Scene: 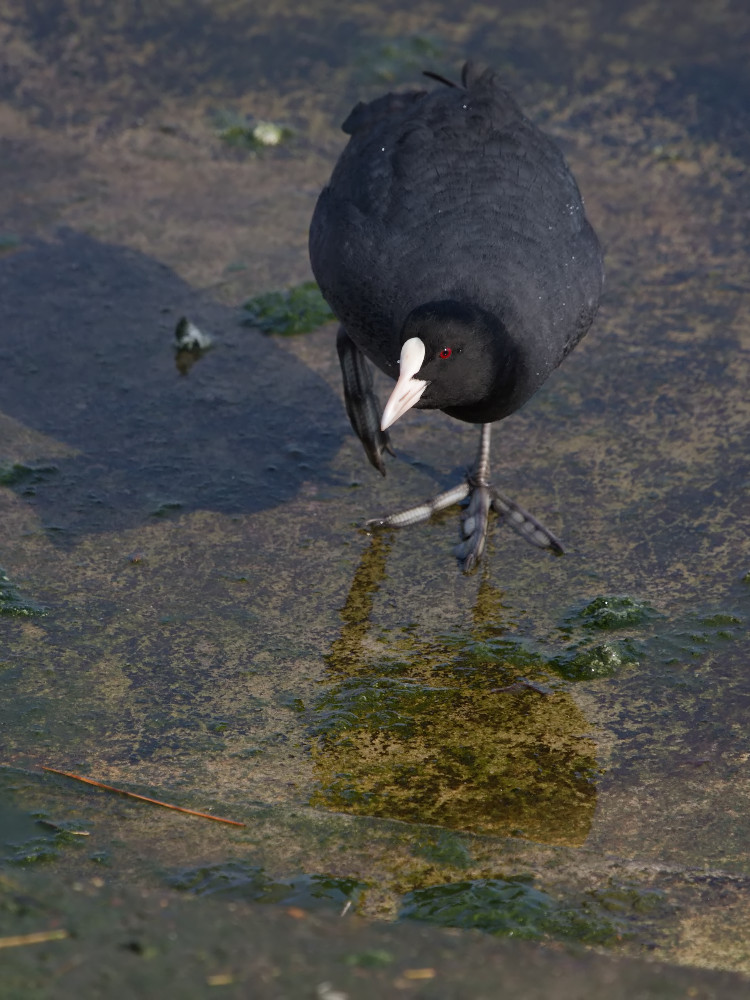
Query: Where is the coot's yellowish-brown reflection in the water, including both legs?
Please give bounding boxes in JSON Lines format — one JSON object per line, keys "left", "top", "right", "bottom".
{"left": 311, "top": 534, "right": 597, "bottom": 845}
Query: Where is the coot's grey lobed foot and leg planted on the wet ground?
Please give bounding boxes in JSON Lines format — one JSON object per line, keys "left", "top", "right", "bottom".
{"left": 367, "top": 424, "right": 563, "bottom": 573}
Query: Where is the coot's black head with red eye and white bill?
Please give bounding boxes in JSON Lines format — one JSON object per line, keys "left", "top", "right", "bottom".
{"left": 381, "top": 299, "right": 516, "bottom": 430}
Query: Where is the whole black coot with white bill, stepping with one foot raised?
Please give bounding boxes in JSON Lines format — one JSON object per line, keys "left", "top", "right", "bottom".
{"left": 310, "top": 63, "right": 603, "bottom": 571}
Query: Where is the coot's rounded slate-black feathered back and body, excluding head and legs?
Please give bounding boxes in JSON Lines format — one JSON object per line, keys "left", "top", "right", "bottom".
{"left": 310, "top": 64, "right": 602, "bottom": 419}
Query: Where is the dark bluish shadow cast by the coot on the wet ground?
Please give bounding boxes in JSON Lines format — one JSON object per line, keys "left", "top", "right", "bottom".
{"left": 0, "top": 231, "right": 347, "bottom": 543}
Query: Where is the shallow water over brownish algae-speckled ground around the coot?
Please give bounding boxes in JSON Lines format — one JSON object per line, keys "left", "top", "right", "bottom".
{"left": 0, "top": 2, "right": 750, "bottom": 996}
